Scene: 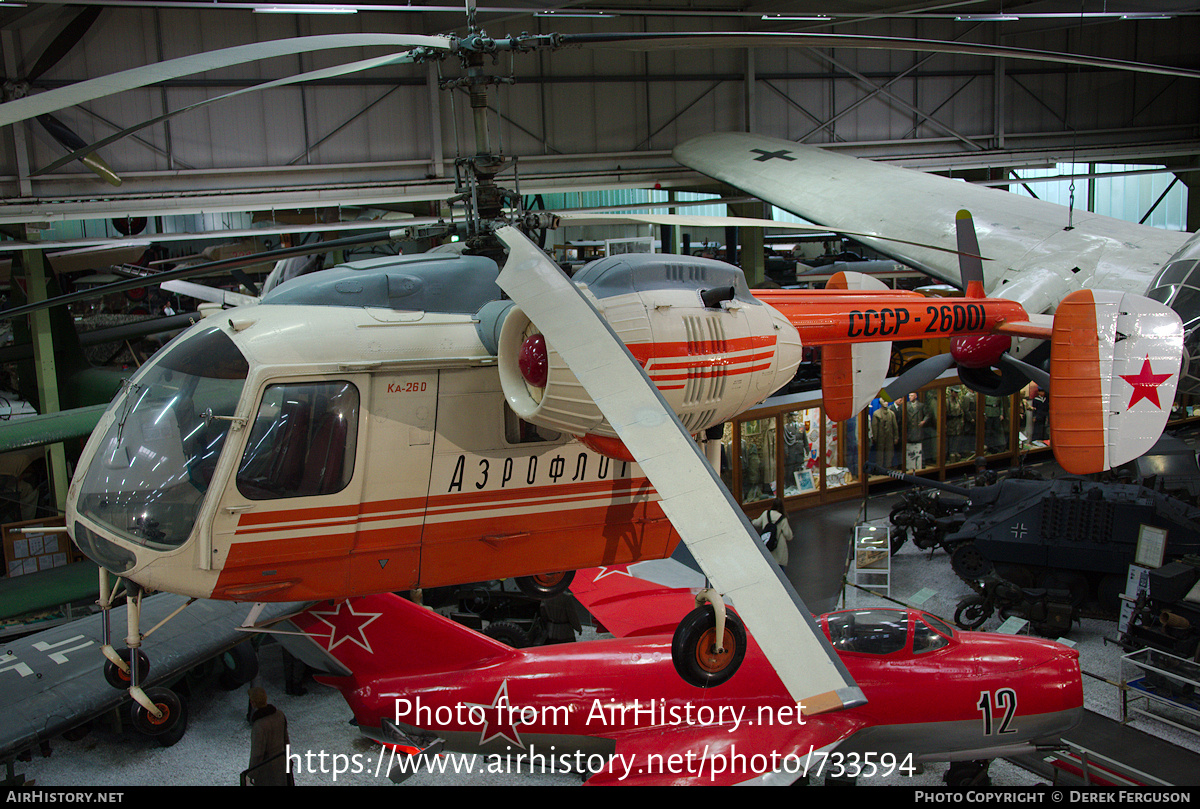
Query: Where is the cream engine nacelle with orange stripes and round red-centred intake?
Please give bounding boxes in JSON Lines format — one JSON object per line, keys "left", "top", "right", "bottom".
{"left": 497, "top": 253, "right": 800, "bottom": 457}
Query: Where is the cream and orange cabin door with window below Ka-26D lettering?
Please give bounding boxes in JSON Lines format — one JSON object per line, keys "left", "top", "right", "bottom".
{"left": 212, "top": 373, "right": 371, "bottom": 601}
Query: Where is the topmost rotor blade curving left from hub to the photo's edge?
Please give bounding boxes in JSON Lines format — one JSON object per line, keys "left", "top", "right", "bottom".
{"left": 0, "top": 34, "right": 450, "bottom": 126}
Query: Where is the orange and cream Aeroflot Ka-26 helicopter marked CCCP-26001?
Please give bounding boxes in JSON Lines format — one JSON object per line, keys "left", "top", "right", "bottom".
{"left": 60, "top": 217, "right": 1182, "bottom": 734}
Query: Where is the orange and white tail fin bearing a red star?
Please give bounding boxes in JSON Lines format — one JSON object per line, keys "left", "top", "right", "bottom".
{"left": 1050, "top": 289, "right": 1183, "bottom": 474}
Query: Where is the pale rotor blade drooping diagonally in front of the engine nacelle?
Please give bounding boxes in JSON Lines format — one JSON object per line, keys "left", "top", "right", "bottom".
{"left": 497, "top": 227, "right": 865, "bottom": 714}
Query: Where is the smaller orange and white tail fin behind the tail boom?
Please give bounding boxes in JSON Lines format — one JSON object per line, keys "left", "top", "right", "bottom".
{"left": 821, "top": 272, "right": 892, "bottom": 421}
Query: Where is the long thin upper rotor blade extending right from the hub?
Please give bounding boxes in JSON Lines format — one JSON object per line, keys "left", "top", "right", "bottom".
{"left": 557, "top": 31, "right": 1200, "bottom": 79}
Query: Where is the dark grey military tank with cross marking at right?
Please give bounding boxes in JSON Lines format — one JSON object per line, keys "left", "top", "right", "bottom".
{"left": 943, "top": 477, "right": 1200, "bottom": 611}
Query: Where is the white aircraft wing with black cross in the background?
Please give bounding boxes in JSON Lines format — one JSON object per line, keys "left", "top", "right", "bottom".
{"left": 674, "top": 132, "right": 1189, "bottom": 313}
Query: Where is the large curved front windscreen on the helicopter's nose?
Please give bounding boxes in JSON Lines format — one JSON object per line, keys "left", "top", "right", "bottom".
{"left": 77, "top": 328, "right": 250, "bottom": 547}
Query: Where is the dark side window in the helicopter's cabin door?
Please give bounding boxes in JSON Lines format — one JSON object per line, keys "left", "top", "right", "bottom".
{"left": 238, "top": 382, "right": 359, "bottom": 501}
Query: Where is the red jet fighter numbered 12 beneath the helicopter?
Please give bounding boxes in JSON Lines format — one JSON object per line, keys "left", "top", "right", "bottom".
{"left": 281, "top": 567, "right": 1084, "bottom": 785}
